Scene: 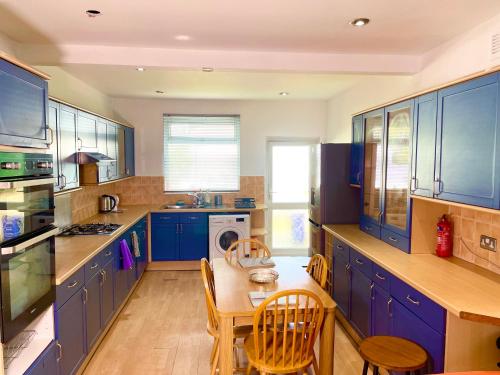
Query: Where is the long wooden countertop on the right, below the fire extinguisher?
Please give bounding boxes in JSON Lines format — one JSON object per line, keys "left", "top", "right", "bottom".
{"left": 323, "top": 225, "right": 500, "bottom": 325}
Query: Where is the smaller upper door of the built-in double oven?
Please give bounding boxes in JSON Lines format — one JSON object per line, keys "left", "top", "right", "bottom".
{"left": 0, "top": 178, "right": 56, "bottom": 242}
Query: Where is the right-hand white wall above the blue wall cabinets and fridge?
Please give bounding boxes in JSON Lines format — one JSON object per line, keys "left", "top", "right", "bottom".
{"left": 327, "top": 15, "right": 500, "bottom": 142}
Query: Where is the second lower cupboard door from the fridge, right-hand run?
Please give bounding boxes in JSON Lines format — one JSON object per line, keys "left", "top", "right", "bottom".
{"left": 350, "top": 266, "right": 373, "bottom": 337}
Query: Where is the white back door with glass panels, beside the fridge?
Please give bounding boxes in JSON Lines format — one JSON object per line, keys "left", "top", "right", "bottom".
{"left": 268, "top": 142, "right": 314, "bottom": 256}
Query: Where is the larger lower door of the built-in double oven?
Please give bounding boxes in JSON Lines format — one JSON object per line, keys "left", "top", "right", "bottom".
{"left": 0, "top": 227, "right": 59, "bottom": 343}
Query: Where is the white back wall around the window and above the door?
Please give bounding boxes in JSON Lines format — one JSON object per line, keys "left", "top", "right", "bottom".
{"left": 112, "top": 98, "right": 327, "bottom": 176}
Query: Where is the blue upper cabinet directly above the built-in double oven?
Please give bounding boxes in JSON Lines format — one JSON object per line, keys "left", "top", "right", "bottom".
{"left": 0, "top": 59, "right": 50, "bottom": 148}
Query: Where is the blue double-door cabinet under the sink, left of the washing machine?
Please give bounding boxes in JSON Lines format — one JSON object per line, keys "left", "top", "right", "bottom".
{"left": 151, "top": 213, "right": 208, "bottom": 261}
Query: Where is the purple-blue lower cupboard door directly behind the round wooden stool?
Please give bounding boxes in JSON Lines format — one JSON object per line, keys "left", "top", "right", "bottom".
{"left": 391, "top": 300, "right": 445, "bottom": 374}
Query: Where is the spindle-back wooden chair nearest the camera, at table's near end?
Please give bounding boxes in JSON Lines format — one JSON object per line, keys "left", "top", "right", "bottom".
{"left": 244, "top": 289, "right": 324, "bottom": 375}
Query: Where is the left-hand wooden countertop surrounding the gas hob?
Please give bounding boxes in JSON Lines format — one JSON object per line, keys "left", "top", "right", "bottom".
{"left": 56, "top": 205, "right": 152, "bottom": 285}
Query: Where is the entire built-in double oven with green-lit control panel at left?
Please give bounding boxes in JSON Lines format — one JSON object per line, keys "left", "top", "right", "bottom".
{"left": 0, "top": 152, "right": 55, "bottom": 342}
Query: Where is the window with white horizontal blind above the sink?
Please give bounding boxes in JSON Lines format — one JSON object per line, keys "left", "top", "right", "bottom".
{"left": 163, "top": 115, "right": 240, "bottom": 192}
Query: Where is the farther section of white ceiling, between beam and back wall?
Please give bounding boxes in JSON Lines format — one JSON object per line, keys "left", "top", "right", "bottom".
{"left": 57, "top": 64, "right": 376, "bottom": 100}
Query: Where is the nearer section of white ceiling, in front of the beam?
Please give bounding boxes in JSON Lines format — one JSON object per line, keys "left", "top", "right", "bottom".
{"left": 0, "top": 0, "right": 500, "bottom": 54}
